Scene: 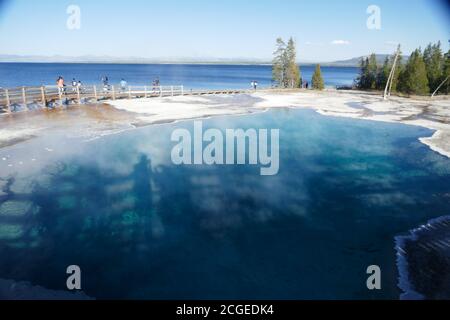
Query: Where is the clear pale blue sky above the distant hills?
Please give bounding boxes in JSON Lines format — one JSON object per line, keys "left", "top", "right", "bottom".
{"left": 0, "top": 0, "right": 450, "bottom": 61}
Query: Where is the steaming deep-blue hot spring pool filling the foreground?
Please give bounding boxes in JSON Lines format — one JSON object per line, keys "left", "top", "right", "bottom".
{"left": 0, "top": 109, "right": 450, "bottom": 299}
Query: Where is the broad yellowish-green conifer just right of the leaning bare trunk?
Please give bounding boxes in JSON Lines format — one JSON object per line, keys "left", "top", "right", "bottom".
{"left": 399, "top": 49, "right": 430, "bottom": 95}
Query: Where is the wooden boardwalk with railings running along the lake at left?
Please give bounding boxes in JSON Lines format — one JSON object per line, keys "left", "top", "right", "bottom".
{"left": 0, "top": 85, "right": 251, "bottom": 113}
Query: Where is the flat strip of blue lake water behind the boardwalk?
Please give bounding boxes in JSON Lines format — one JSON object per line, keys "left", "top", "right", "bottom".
{"left": 0, "top": 63, "right": 358, "bottom": 89}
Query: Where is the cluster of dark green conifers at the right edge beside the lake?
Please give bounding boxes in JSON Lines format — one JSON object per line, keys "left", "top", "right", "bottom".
{"left": 356, "top": 42, "right": 450, "bottom": 95}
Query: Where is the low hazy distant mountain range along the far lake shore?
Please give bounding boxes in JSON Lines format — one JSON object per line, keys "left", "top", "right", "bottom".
{"left": 0, "top": 54, "right": 407, "bottom": 67}
